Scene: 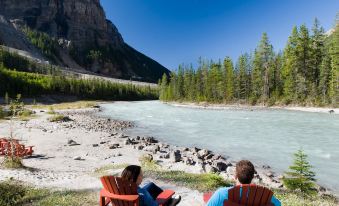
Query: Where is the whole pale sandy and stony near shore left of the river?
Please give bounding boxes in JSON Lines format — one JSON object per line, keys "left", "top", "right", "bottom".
{"left": 0, "top": 103, "right": 338, "bottom": 205}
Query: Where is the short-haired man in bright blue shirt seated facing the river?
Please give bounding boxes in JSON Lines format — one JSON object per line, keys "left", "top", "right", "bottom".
{"left": 207, "top": 160, "right": 281, "bottom": 206}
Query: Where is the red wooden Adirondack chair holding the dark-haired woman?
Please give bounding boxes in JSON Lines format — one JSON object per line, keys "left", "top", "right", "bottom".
{"left": 100, "top": 176, "right": 174, "bottom": 206}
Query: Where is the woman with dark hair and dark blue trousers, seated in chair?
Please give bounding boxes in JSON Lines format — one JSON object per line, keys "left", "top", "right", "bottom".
{"left": 121, "top": 165, "right": 181, "bottom": 206}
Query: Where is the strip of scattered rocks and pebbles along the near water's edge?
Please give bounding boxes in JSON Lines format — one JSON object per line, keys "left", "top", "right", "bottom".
{"left": 56, "top": 109, "right": 292, "bottom": 188}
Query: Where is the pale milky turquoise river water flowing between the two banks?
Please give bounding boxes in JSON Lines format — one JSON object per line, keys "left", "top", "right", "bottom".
{"left": 101, "top": 101, "right": 339, "bottom": 194}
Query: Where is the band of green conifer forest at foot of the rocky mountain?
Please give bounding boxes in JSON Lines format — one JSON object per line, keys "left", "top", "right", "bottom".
{"left": 0, "top": 48, "right": 159, "bottom": 100}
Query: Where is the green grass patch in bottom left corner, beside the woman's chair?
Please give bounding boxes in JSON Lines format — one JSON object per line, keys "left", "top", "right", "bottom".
{"left": 0, "top": 180, "right": 98, "bottom": 206}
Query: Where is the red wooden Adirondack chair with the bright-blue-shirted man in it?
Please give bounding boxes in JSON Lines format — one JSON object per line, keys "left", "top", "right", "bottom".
{"left": 204, "top": 184, "right": 273, "bottom": 206}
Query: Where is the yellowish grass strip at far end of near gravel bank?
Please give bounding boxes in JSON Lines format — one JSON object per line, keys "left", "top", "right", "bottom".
{"left": 31, "top": 101, "right": 98, "bottom": 111}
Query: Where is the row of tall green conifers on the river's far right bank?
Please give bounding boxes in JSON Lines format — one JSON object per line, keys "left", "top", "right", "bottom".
{"left": 159, "top": 19, "right": 339, "bottom": 106}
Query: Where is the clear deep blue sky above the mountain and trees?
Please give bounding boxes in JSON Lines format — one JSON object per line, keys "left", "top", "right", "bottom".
{"left": 101, "top": 0, "right": 339, "bottom": 70}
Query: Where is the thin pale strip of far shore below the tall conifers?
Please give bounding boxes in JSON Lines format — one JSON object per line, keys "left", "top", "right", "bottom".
{"left": 166, "top": 102, "right": 339, "bottom": 115}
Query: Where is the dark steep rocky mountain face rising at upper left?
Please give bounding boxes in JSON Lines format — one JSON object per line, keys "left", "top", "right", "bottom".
{"left": 0, "top": 0, "right": 169, "bottom": 82}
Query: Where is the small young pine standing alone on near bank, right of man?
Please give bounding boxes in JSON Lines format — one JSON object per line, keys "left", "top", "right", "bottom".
{"left": 283, "top": 149, "right": 315, "bottom": 195}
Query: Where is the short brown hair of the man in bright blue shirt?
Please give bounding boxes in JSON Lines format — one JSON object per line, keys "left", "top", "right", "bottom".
{"left": 235, "top": 160, "right": 255, "bottom": 184}
